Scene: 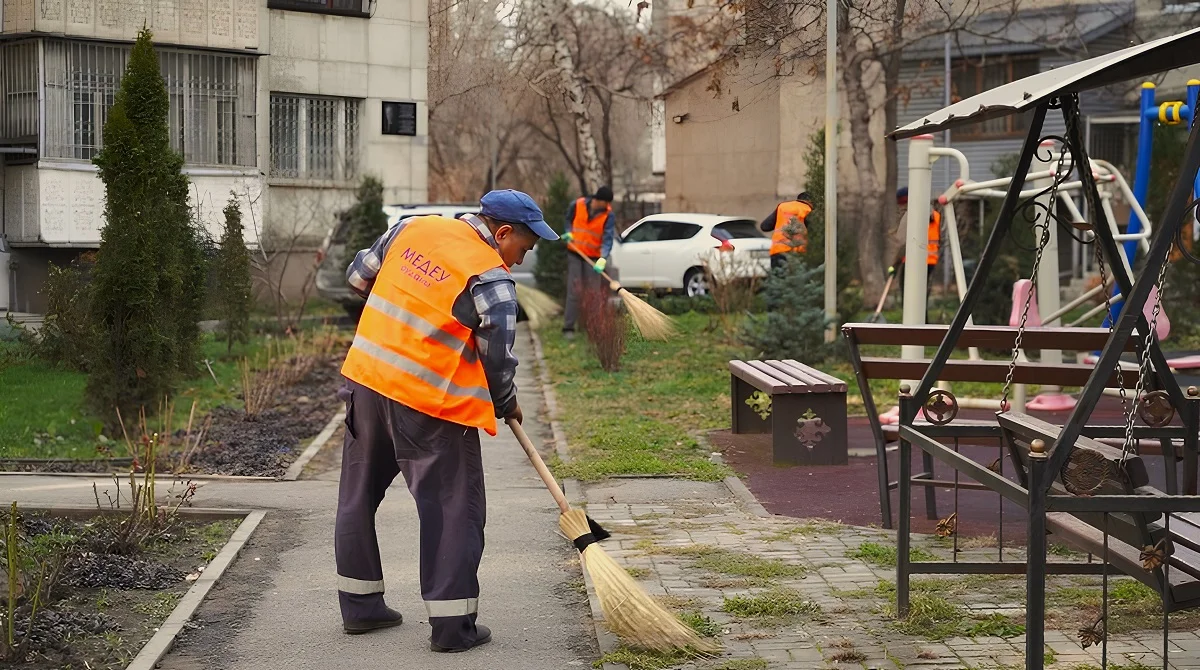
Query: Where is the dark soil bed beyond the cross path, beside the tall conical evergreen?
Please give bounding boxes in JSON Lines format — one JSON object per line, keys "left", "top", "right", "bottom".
{"left": 0, "top": 353, "right": 343, "bottom": 477}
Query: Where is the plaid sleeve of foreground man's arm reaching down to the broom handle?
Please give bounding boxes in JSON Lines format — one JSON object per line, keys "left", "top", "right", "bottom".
{"left": 468, "top": 268, "right": 517, "bottom": 417}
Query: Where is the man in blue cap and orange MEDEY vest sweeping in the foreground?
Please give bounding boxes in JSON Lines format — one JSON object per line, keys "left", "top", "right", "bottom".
{"left": 334, "top": 191, "right": 558, "bottom": 652}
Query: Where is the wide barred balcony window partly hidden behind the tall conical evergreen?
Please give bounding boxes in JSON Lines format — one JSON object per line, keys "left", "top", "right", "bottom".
{"left": 46, "top": 41, "right": 257, "bottom": 166}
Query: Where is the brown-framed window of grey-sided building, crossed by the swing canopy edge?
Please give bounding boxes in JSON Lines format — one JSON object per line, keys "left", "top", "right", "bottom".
{"left": 950, "top": 56, "right": 1039, "bottom": 139}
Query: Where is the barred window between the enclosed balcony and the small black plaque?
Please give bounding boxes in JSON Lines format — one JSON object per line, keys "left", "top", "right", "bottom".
{"left": 271, "top": 94, "right": 362, "bottom": 181}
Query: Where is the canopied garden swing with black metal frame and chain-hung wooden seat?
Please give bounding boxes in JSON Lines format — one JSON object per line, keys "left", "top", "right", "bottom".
{"left": 893, "top": 29, "right": 1200, "bottom": 670}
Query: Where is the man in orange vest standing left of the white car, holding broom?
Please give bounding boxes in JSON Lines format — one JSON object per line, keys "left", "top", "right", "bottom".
{"left": 563, "top": 186, "right": 617, "bottom": 339}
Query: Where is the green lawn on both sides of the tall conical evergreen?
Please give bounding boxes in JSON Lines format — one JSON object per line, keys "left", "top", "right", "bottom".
{"left": 0, "top": 335, "right": 282, "bottom": 459}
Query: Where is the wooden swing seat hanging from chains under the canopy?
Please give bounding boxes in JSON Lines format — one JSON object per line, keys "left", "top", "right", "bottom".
{"left": 998, "top": 412, "right": 1200, "bottom": 612}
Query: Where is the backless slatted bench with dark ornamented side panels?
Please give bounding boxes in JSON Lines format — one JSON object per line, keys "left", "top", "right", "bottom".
{"left": 730, "top": 360, "right": 848, "bottom": 465}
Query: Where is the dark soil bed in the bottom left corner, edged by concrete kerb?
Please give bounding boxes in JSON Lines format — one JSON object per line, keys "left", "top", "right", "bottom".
{"left": 0, "top": 513, "right": 240, "bottom": 670}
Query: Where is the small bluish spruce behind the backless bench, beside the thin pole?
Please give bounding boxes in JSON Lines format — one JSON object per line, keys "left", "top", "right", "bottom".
{"left": 742, "top": 256, "right": 830, "bottom": 364}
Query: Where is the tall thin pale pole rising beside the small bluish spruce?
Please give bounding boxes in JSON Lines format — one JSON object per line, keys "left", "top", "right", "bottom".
{"left": 824, "top": 0, "right": 838, "bottom": 342}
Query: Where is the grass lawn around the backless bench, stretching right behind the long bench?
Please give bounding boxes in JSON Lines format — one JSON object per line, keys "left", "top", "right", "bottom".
{"left": 539, "top": 300, "right": 1128, "bottom": 480}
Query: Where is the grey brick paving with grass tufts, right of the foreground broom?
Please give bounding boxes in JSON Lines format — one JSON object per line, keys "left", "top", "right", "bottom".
{"left": 587, "top": 480, "right": 1200, "bottom": 670}
